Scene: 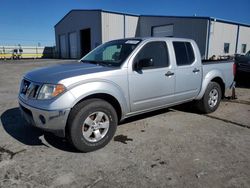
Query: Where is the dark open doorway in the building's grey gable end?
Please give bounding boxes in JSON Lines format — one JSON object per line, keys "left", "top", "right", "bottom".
{"left": 81, "top": 28, "right": 91, "bottom": 57}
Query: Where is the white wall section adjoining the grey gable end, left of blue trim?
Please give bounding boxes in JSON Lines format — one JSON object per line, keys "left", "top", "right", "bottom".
{"left": 102, "top": 12, "right": 124, "bottom": 43}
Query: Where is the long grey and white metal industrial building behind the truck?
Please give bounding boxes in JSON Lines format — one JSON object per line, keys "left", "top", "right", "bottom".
{"left": 55, "top": 10, "right": 250, "bottom": 59}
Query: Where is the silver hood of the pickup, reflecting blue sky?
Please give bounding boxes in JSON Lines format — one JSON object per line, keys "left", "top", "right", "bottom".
{"left": 24, "top": 63, "right": 116, "bottom": 83}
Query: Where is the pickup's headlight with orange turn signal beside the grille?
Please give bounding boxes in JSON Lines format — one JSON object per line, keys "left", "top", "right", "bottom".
{"left": 38, "top": 84, "right": 65, "bottom": 99}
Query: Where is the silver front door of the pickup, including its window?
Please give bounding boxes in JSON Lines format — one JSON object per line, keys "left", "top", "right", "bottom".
{"left": 128, "top": 41, "right": 175, "bottom": 112}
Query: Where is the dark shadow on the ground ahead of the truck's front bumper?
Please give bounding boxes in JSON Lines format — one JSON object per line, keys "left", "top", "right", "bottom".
{"left": 1, "top": 108, "right": 77, "bottom": 152}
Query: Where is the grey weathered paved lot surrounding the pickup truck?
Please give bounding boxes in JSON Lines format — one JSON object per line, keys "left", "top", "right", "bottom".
{"left": 0, "top": 59, "right": 250, "bottom": 188}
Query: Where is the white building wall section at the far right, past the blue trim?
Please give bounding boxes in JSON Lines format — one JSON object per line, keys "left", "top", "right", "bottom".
{"left": 237, "top": 26, "right": 250, "bottom": 54}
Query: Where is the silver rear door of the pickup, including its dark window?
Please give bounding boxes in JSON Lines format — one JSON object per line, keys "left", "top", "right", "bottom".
{"left": 173, "top": 41, "right": 202, "bottom": 101}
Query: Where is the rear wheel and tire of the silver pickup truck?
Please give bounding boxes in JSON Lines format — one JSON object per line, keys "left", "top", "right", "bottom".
{"left": 197, "top": 82, "right": 222, "bottom": 114}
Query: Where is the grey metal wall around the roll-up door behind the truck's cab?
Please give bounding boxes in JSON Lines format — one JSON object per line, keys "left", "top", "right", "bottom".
{"left": 140, "top": 16, "right": 207, "bottom": 58}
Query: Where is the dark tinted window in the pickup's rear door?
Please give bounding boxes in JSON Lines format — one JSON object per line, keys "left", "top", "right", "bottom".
{"left": 173, "top": 42, "right": 195, "bottom": 66}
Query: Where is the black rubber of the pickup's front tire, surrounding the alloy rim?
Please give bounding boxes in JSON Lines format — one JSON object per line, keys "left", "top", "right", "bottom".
{"left": 70, "top": 100, "right": 117, "bottom": 152}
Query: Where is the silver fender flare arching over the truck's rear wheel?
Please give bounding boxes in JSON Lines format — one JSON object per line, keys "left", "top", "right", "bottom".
{"left": 196, "top": 70, "right": 224, "bottom": 100}
